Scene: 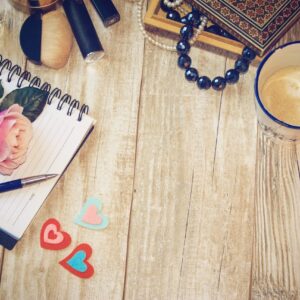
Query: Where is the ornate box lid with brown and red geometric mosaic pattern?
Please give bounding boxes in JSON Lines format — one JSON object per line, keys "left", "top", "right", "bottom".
{"left": 188, "top": 0, "right": 300, "bottom": 56}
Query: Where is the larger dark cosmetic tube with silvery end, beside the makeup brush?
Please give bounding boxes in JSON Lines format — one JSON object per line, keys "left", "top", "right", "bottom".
{"left": 63, "top": 0, "right": 104, "bottom": 62}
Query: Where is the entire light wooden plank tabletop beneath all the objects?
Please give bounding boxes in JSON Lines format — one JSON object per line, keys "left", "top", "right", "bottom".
{"left": 0, "top": 0, "right": 300, "bottom": 300}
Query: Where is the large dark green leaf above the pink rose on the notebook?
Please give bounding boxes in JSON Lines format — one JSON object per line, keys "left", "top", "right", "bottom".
{"left": 0, "top": 87, "right": 48, "bottom": 122}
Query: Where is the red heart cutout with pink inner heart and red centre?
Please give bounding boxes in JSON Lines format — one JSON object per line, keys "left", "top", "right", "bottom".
{"left": 40, "top": 218, "right": 71, "bottom": 250}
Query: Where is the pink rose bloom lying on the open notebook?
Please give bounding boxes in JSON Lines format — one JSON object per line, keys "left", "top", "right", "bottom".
{"left": 0, "top": 104, "right": 32, "bottom": 175}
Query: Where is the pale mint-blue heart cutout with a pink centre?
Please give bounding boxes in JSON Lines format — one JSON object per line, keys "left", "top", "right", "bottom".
{"left": 74, "top": 198, "right": 108, "bottom": 230}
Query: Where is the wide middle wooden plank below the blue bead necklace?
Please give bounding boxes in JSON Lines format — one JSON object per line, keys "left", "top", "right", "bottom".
{"left": 125, "top": 28, "right": 256, "bottom": 299}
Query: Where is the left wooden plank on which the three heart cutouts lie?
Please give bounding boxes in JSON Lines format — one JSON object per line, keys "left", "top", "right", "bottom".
{"left": 0, "top": 1, "right": 144, "bottom": 300}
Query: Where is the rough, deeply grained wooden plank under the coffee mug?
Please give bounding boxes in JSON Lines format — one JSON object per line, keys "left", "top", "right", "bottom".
{"left": 252, "top": 22, "right": 300, "bottom": 299}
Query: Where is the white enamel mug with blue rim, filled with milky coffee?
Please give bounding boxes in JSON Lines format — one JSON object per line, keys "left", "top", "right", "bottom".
{"left": 255, "top": 42, "right": 300, "bottom": 141}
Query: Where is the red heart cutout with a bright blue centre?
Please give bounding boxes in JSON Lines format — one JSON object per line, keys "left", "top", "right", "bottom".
{"left": 59, "top": 244, "right": 94, "bottom": 278}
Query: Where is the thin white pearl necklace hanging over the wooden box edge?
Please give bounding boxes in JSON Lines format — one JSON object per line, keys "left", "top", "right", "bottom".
{"left": 137, "top": 0, "right": 207, "bottom": 52}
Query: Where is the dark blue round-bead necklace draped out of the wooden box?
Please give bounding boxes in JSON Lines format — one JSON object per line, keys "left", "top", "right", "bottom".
{"left": 160, "top": 0, "right": 256, "bottom": 91}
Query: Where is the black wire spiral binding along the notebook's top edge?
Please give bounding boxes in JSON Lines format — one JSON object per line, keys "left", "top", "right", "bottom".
{"left": 0, "top": 54, "right": 89, "bottom": 121}
